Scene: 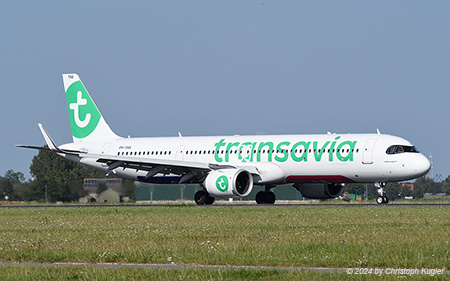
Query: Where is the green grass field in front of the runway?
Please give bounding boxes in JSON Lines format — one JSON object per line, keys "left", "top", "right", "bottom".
{"left": 0, "top": 203, "right": 450, "bottom": 280}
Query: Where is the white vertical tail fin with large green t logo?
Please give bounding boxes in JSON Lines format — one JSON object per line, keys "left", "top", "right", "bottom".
{"left": 63, "top": 74, "right": 120, "bottom": 142}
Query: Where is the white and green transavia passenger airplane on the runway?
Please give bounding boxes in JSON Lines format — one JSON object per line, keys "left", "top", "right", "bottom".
{"left": 17, "top": 73, "right": 431, "bottom": 205}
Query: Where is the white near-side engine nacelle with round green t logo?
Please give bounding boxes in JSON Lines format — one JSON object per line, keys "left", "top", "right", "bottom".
{"left": 203, "top": 169, "right": 253, "bottom": 198}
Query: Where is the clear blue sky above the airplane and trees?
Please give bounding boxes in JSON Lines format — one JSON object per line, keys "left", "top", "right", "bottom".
{"left": 0, "top": 1, "right": 450, "bottom": 178}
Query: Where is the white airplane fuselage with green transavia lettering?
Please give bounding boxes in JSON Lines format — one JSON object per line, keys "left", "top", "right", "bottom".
{"left": 61, "top": 134, "right": 430, "bottom": 185}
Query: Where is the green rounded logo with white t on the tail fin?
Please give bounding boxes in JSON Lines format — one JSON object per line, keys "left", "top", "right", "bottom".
{"left": 66, "top": 81, "right": 101, "bottom": 139}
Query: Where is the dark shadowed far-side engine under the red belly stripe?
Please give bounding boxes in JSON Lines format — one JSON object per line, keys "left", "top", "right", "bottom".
{"left": 294, "top": 183, "right": 344, "bottom": 199}
